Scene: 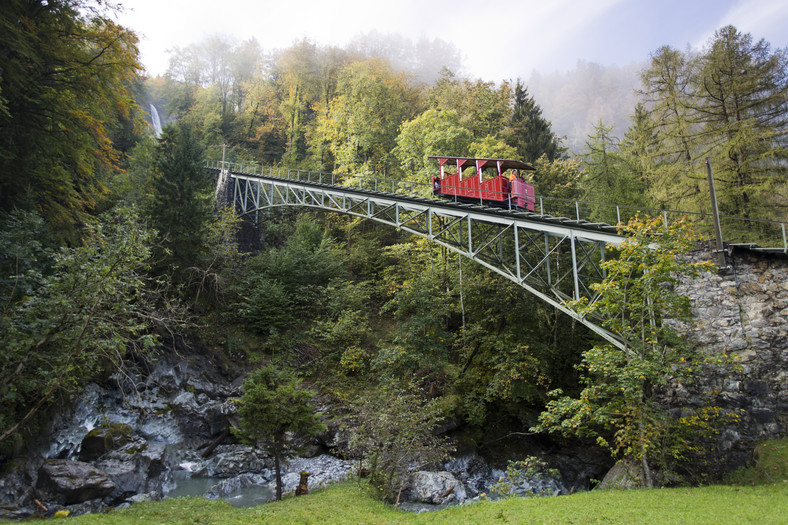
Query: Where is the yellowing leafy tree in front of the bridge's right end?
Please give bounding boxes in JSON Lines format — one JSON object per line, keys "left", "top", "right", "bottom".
{"left": 535, "top": 218, "right": 712, "bottom": 486}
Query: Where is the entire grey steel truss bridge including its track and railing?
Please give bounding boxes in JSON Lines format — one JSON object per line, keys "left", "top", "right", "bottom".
{"left": 206, "top": 162, "right": 788, "bottom": 348}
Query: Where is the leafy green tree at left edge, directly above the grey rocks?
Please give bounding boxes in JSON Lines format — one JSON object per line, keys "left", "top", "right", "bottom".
{"left": 0, "top": 210, "right": 168, "bottom": 447}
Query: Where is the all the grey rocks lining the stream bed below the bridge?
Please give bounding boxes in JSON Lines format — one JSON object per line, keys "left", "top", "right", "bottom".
{"left": 0, "top": 340, "right": 616, "bottom": 519}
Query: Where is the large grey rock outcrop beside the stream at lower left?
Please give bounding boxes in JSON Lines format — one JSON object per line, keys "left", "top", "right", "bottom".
{"left": 0, "top": 344, "right": 243, "bottom": 518}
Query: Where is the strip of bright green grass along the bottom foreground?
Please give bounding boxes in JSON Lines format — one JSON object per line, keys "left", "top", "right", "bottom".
{"left": 43, "top": 482, "right": 788, "bottom": 525}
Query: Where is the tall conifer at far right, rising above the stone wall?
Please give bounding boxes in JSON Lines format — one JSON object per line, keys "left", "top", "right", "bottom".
{"left": 691, "top": 26, "right": 788, "bottom": 217}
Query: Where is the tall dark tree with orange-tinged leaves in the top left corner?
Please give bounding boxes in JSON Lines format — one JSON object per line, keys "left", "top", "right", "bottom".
{"left": 0, "top": 0, "right": 141, "bottom": 233}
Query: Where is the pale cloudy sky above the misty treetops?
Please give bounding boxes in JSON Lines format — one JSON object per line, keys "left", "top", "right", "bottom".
{"left": 119, "top": 0, "right": 788, "bottom": 82}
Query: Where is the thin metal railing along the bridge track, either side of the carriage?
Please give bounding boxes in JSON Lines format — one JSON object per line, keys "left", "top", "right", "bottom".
{"left": 206, "top": 161, "right": 788, "bottom": 253}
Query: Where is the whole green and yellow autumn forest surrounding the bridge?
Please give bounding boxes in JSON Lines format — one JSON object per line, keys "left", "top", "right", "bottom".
{"left": 0, "top": 0, "right": 788, "bottom": 500}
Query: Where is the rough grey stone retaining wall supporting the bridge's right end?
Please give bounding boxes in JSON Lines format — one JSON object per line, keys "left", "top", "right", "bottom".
{"left": 670, "top": 247, "right": 788, "bottom": 464}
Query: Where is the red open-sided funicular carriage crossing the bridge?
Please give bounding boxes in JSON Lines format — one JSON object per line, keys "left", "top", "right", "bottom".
{"left": 428, "top": 156, "right": 536, "bottom": 211}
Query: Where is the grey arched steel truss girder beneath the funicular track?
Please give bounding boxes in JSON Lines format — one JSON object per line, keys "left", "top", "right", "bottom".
{"left": 223, "top": 169, "right": 624, "bottom": 348}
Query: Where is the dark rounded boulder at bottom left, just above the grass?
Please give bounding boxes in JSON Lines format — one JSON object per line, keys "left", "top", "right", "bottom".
{"left": 36, "top": 459, "right": 115, "bottom": 505}
